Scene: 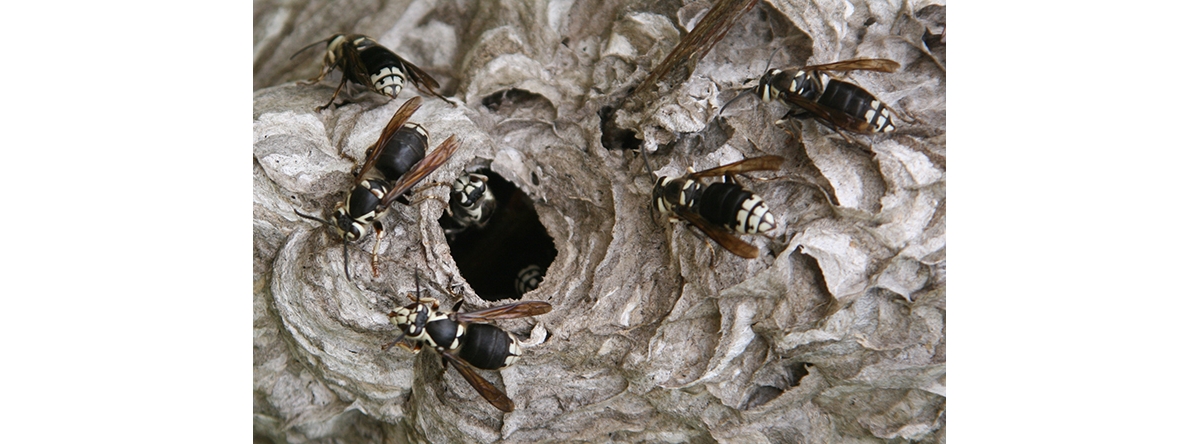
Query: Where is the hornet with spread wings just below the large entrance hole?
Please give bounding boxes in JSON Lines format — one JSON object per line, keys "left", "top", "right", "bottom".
{"left": 383, "top": 289, "right": 551, "bottom": 412}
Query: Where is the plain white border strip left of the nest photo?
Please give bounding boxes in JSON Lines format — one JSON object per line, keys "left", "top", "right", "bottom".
{"left": 0, "top": 1, "right": 253, "bottom": 443}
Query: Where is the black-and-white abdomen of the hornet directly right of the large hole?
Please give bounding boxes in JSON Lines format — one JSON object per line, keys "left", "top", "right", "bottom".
{"left": 696, "top": 182, "right": 775, "bottom": 234}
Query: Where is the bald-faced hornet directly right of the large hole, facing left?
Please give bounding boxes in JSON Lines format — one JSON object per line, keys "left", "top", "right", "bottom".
{"left": 642, "top": 151, "right": 784, "bottom": 259}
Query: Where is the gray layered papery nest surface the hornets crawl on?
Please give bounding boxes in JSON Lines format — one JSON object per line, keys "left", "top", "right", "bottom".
{"left": 253, "top": 0, "right": 946, "bottom": 443}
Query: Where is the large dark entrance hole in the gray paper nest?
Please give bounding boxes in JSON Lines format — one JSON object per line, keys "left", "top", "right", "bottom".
{"left": 438, "top": 169, "right": 558, "bottom": 301}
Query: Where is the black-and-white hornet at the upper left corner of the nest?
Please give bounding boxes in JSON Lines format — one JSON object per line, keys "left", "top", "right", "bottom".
{"left": 292, "top": 34, "right": 449, "bottom": 112}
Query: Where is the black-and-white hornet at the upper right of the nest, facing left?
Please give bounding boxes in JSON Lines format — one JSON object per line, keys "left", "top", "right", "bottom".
{"left": 753, "top": 59, "right": 900, "bottom": 140}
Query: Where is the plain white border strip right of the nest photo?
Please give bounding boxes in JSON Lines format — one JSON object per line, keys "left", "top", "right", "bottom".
{"left": 947, "top": 0, "right": 1200, "bottom": 443}
